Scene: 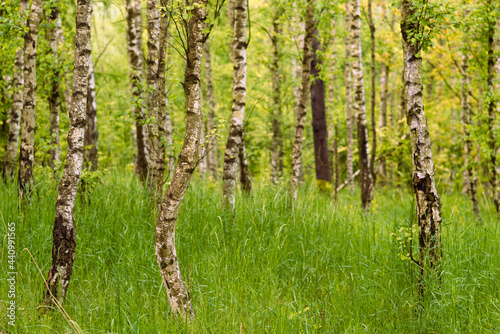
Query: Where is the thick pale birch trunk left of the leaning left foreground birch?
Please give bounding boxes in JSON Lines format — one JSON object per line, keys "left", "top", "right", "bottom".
{"left": 18, "top": 0, "right": 43, "bottom": 197}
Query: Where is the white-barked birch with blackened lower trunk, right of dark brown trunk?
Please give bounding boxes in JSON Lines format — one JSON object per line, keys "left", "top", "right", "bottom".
{"left": 351, "top": 0, "right": 373, "bottom": 212}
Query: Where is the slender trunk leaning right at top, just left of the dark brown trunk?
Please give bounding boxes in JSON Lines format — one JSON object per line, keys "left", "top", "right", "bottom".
{"left": 290, "top": 0, "right": 315, "bottom": 200}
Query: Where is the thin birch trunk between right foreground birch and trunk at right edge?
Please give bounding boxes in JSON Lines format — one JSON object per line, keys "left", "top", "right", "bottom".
{"left": 461, "top": 53, "right": 481, "bottom": 216}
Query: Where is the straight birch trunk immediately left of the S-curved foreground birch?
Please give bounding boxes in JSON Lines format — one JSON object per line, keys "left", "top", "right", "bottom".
{"left": 146, "top": 0, "right": 165, "bottom": 196}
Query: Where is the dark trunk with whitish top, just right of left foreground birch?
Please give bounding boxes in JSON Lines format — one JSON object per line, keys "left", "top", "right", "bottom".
{"left": 84, "top": 57, "right": 99, "bottom": 171}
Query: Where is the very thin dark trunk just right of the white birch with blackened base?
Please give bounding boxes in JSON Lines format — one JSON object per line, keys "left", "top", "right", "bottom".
{"left": 368, "top": 0, "right": 377, "bottom": 183}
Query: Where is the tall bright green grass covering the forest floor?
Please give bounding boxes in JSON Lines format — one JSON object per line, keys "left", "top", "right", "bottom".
{"left": 0, "top": 171, "right": 500, "bottom": 333}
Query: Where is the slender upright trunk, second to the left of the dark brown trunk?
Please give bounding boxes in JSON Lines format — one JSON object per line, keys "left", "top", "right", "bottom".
{"left": 271, "top": 4, "right": 283, "bottom": 184}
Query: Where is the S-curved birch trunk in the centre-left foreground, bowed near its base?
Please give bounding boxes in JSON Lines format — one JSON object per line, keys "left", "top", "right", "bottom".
{"left": 155, "top": 0, "right": 207, "bottom": 317}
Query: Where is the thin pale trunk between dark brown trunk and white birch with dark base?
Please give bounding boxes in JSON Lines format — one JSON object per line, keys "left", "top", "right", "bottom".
{"left": 345, "top": 1, "right": 354, "bottom": 192}
